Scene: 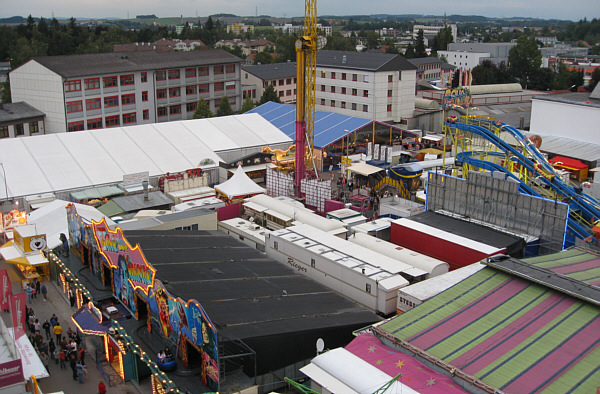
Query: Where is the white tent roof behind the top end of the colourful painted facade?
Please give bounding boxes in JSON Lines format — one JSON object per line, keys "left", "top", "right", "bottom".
{"left": 27, "top": 200, "right": 115, "bottom": 249}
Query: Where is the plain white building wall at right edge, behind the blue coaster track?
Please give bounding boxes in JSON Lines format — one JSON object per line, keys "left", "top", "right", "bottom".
{"left": 531, "top": 98, "right": 600, "bottom": 142}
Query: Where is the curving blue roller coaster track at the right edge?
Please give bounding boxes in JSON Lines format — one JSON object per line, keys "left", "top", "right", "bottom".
{"left": 446, "top": 118, "right": 600, "bottom": 239}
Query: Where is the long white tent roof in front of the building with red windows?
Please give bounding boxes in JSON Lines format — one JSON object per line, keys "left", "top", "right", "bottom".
{"left": 0, "top": 114, "right": 292, "bottom": 199}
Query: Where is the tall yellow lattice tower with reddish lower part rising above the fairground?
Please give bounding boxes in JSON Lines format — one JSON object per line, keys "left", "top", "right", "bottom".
{"left": 294, "top": 0, "right": 324, "bottom": 197}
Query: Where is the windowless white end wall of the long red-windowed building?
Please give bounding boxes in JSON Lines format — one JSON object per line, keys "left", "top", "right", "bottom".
{"left": 9, "top": 60, "right": 67, "bottom": 134}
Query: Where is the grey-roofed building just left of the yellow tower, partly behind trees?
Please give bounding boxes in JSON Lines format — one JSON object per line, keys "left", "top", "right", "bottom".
{"left": 242, "top": 62, "right": 296, "bottom": 104}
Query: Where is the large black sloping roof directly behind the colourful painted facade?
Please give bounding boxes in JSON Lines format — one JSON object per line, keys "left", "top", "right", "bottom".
{"left": 125, "top": 230, "right": 380, "bottom": 339}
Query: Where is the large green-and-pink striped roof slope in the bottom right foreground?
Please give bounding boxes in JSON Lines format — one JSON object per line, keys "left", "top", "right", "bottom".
{"left": 381, "top": 268, "right": 600, "bottom": 393}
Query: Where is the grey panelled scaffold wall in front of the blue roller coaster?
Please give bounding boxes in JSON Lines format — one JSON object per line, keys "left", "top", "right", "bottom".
{"left": 426, "top": 171, "right": 569, "bottom": 255}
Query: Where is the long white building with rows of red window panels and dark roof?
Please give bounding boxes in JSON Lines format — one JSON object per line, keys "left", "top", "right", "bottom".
{"left": 10, "top": 50, "right": 242, "bottom": 134}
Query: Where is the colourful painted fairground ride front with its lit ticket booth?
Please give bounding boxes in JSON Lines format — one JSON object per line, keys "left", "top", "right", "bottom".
{"left": 51, "top": 204, "right": 219, "bottom": 393}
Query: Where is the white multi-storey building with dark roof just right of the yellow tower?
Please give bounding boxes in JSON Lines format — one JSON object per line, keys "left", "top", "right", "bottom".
{"left": 315, "top": 51, "right": 417, "bottom": 123}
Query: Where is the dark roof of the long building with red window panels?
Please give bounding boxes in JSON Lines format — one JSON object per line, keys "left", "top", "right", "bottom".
{"left": 31, "top": 49, "right": 243, "bottom": 78}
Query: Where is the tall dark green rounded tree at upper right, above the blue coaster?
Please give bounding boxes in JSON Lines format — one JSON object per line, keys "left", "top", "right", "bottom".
{"left": 508, "top": 36, "right": 542, "bottom": 88}
